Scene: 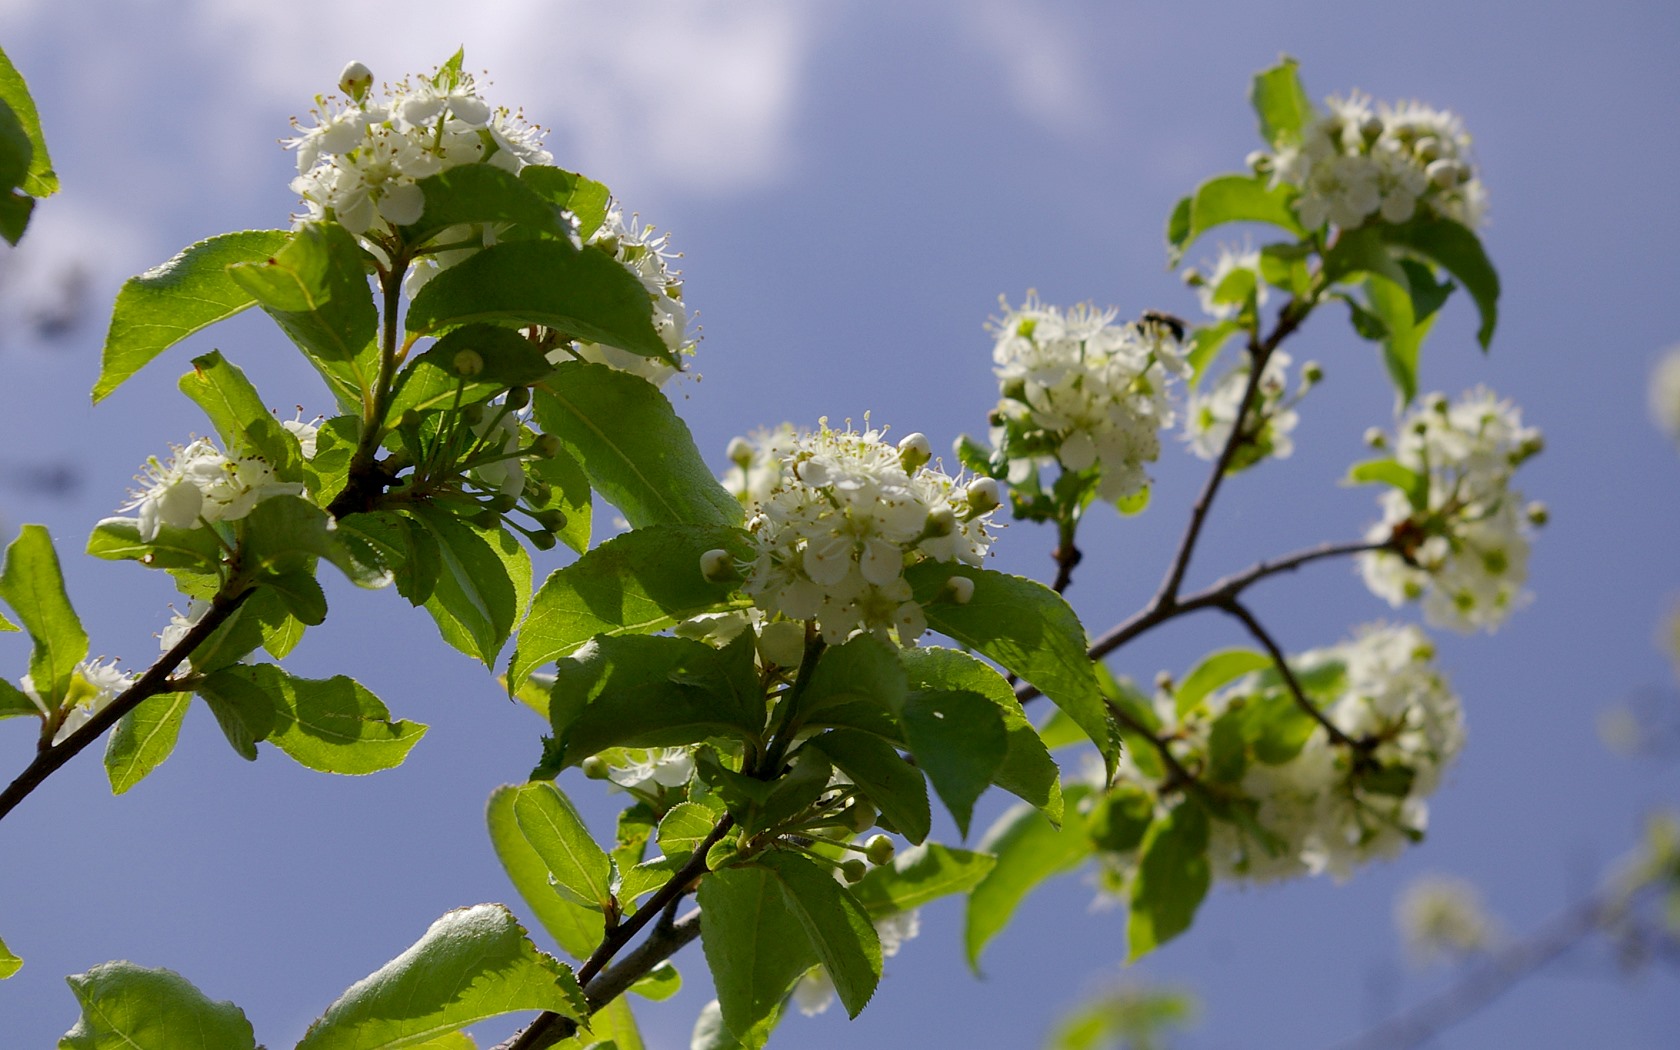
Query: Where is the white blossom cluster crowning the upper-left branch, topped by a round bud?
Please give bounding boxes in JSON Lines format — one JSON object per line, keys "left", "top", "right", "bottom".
{"left": 286, "top": 62, "right": 553, "bottom": 235}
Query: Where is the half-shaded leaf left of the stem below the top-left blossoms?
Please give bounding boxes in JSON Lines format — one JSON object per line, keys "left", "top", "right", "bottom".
{"left": 228, "top": 222, "right": 380, "bottom": 412}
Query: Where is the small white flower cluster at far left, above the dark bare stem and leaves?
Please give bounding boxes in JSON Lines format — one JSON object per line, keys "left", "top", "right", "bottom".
{"left": 121, "top": 433, "right": 316, "bottom": 543}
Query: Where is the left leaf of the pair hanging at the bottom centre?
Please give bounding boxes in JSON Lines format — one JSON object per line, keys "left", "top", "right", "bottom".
{"left": 697, "top": 864, "right": 819, "bottom": 1047}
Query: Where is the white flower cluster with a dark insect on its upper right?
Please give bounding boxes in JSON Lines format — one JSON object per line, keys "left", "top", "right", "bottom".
{"left": 990, "top": 296, "right": 1189, "bottom": 501}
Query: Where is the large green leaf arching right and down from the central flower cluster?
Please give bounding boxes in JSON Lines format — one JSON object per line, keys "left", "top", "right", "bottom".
{"left": 904, "top": 561, "right": 1119, "bottom": 774}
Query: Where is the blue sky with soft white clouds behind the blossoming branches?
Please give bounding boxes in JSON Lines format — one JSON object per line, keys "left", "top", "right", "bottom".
{"left": 0, "top": 0, "right": 1680, "bottom": 1050}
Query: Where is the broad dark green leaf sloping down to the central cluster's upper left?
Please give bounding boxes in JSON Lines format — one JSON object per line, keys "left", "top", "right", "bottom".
{"left": 536, "top": 366, "right": 743, "bottom": 529}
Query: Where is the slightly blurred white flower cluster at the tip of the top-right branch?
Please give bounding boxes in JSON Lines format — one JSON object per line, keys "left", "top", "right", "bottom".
{"left": 1250, "top": 92, "right": 1487, "bottom": 230}
